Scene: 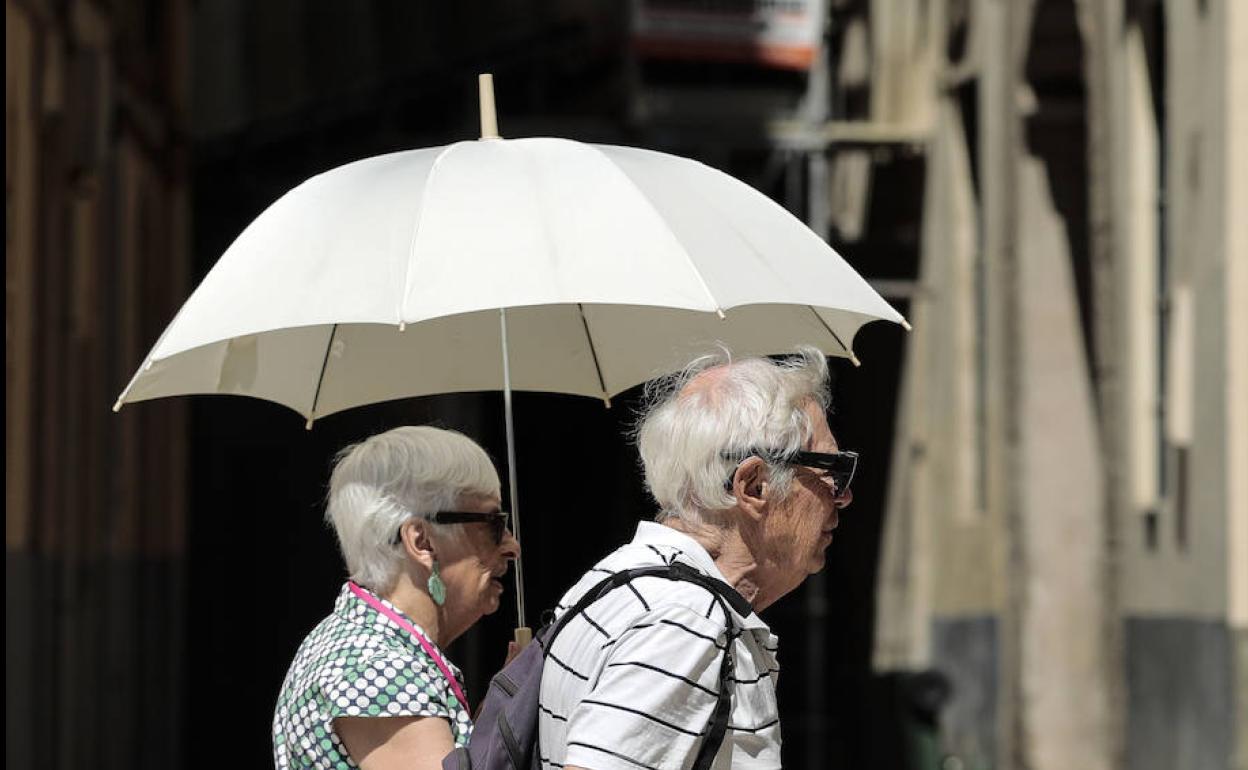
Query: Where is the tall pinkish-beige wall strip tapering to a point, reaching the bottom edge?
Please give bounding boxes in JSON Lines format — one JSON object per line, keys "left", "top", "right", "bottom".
{"left": 1010, "top": 151, "right": 1112, "bottom": 770}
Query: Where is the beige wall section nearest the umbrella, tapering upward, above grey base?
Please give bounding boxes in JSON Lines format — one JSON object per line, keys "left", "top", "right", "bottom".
{"left": 875, "top": 89, "right": 1003, "bottom": 668}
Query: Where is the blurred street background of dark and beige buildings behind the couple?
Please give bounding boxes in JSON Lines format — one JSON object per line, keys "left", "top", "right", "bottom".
{"left": 5, "top": 0, "right": 1248, "bottom": 770}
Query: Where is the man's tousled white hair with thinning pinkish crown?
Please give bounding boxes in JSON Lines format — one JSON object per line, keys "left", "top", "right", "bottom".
{"left": 636, "top": 347, "right": 831, "bottom": 524}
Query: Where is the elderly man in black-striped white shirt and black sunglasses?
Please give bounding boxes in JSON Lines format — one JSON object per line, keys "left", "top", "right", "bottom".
{"left": 539, "top": 348, "right": 856, "bottom": 770}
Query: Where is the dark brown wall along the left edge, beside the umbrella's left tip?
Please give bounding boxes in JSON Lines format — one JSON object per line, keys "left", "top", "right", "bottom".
{"left": 5, "top": 0, "right": 188, "bottom": 768}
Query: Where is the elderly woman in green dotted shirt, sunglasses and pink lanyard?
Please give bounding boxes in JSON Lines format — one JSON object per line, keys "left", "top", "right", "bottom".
{"left": 273, "top": 427, "right": 519, "bottom": 770}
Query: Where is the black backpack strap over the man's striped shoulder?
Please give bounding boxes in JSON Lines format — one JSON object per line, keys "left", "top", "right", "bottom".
{"left": 543, "top": 562, "right": 754, "bottom": 770}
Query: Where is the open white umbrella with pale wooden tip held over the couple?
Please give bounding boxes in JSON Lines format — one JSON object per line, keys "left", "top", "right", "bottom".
{"left": 114, "top": 76, "right": 909, "bottom": 636}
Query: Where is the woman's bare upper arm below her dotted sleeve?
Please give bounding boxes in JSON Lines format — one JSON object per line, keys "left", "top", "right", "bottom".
{"left": 333, "top": 716, "right": 456, "bottom": 770}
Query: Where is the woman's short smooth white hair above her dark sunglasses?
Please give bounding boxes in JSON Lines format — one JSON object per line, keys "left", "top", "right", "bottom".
{"left": 324, "top": 426, "right": 499, "bottom": 592}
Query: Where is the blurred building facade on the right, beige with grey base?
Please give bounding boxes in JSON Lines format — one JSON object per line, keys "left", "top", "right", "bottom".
{"left": 870, "top": 0, "right": 1248, "bottom": 769}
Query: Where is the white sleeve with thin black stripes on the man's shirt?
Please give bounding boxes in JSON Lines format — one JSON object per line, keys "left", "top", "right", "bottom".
{"left": 564, "top": 605, "right": 728, "bottom": 770}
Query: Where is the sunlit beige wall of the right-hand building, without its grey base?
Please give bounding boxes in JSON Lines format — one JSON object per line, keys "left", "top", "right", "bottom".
{"left": 872, "top": 0, "right": 1248, "bottom": 769}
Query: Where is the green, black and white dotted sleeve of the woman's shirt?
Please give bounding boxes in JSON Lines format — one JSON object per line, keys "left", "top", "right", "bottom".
{"left": 318, "top": 654, "right": 452, "bottom": 720}
